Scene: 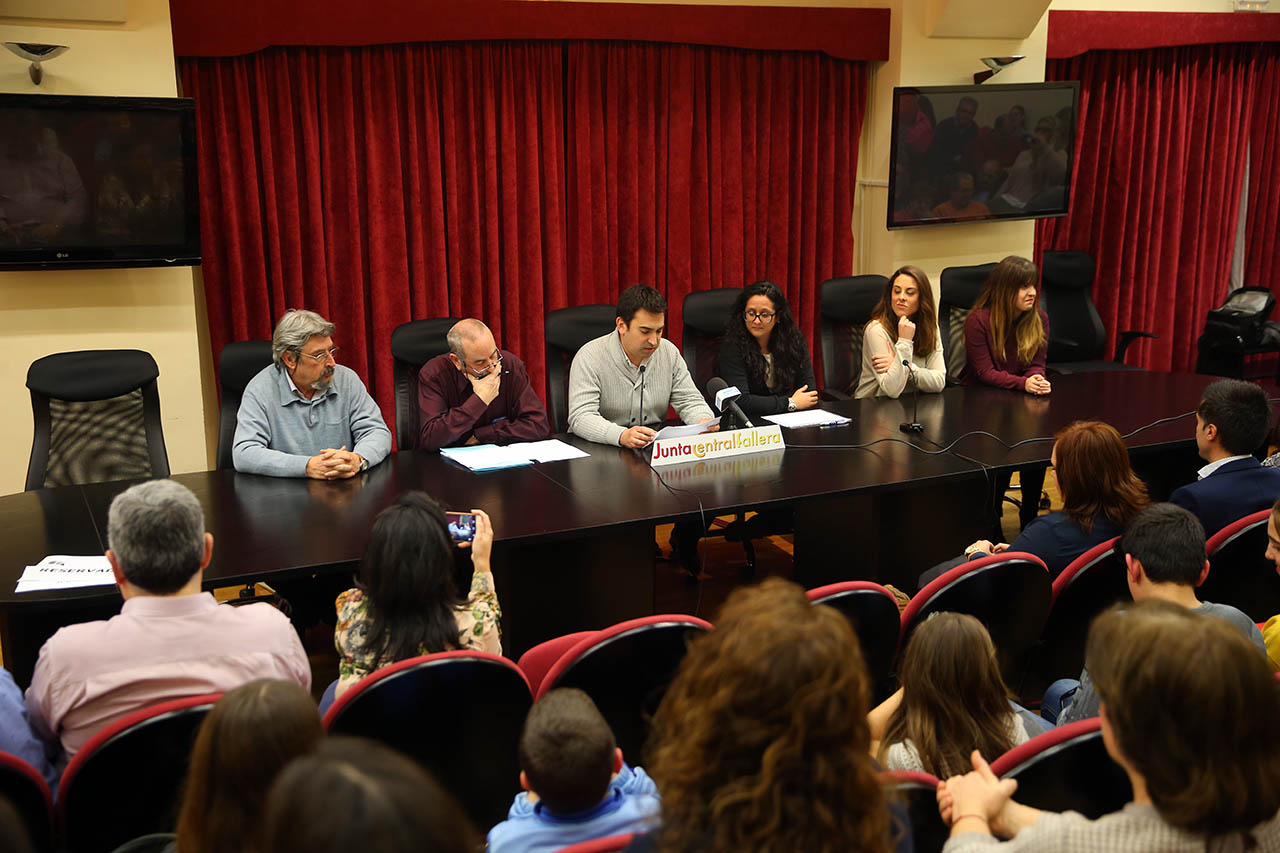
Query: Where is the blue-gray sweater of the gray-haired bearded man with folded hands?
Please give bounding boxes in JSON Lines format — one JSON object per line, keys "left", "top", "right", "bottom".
{"left": 232, "top": 364, "right": 392, "bottom": 476}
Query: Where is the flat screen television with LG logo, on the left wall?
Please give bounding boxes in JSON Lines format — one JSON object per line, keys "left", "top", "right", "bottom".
{"left": 0, "top": 95, "right": 200, "bottom": 270}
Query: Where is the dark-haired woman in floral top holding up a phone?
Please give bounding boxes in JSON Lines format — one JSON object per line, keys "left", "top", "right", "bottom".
{"left": 334, "top": 492, "right": 502, "bottom": 695}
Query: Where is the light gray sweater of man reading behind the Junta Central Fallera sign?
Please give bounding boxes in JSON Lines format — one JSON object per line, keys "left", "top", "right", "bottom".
{"left": 568, "top": 330, "right": 714, "bottom": 444}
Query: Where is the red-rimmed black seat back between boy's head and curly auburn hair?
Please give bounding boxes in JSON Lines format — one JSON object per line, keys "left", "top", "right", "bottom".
{"left": 538, "top": 613, "right": 712, "bottom": 761}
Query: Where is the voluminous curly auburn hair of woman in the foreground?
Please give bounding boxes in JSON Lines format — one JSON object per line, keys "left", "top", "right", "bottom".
{"left": 646, "top": 578, "right": 890, "bottom": 853}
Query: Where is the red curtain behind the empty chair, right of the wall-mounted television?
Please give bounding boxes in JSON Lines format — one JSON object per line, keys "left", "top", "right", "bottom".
{"left": 1036, "top": 45, "right": 1254, "bottom": 371}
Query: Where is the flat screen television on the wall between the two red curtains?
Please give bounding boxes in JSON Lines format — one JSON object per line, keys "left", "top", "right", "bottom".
{"left": 886, "top": 82, "right": 1080, "bottom": 228}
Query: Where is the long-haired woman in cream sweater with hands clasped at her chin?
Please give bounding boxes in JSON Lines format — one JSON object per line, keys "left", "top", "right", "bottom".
{"left": 854, "top": 265, "right": 947, "bottom": 398}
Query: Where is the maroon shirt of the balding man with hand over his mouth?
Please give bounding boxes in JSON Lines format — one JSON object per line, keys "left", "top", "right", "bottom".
{"left": 417, "top": 350, "right": 552, "bottom": 450}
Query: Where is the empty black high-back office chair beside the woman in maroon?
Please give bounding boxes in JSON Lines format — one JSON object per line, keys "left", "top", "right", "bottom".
{"left": 1041, "top": 251, "right": 1160, "bottom": 375}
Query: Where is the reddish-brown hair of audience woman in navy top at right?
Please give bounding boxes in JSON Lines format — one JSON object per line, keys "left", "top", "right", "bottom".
{"left": 1053, "top": 420, "right": 1151, "bottom": 533}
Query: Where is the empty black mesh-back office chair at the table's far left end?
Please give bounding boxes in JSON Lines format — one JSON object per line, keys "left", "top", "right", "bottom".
{"left": 26, "top": 350, "right": 169, "bottom": 492}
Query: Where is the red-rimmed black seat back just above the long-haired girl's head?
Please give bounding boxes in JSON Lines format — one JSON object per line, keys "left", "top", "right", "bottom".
{"left": 901, "top": 551, "right": 1052, "bottom": 690}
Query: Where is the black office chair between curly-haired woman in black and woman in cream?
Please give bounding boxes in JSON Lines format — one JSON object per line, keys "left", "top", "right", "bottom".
{"left": 818, "top": 275, "right": 888, "bottom": 400}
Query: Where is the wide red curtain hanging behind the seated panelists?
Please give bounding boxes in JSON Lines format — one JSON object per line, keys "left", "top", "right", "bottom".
{"left": 180, "top": 42, "right": 865, "bottom": 435}
